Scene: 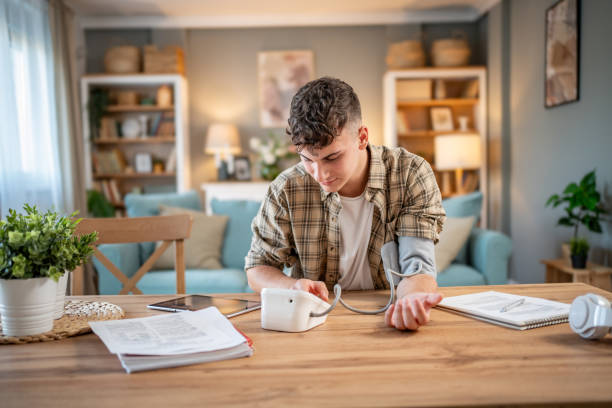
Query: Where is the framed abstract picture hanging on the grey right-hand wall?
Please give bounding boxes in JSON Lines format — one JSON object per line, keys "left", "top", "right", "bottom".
{"left": 545, "top": 0, "right": 580, "bottom": 108}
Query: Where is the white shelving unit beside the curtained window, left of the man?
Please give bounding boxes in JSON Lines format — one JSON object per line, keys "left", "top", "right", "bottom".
{"left": 81, "top": 74, "right": 191, "bottom": 208}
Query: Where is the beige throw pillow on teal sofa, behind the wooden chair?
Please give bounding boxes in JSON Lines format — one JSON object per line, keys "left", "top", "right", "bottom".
{"left": 153, "top": 205, "right": 229, "bottom": 269}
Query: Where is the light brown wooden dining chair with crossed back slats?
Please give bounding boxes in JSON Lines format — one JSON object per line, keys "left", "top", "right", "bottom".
{"left": 71, "top": 214, "right": 193, "bottom": 295}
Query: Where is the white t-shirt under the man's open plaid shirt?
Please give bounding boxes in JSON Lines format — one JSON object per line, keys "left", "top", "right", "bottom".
{"left": 338, "top": 190, "right": 374, "bottom": 290}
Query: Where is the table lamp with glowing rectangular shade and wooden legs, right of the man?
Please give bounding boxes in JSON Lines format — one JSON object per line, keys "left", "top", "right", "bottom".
{"left": 434, "top": 134, "right": 481, "bottom": 195}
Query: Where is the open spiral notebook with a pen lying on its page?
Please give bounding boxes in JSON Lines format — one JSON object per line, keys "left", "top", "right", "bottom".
{"left": 438, "top": 290, "right": 570, "bottom": 330}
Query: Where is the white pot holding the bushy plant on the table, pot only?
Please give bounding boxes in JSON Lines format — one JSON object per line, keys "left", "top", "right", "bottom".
{"left": 0, "top": 278, "right": 57, "bottom": 336}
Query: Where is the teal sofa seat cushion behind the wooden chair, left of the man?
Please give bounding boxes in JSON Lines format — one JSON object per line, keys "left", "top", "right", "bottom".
{"left": 136, "top": 269, "right": 251, "bottom": 295}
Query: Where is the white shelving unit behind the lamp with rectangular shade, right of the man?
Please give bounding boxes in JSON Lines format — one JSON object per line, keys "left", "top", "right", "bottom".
{"left": 383, "top": 67, "right": 488, "bottom": 228}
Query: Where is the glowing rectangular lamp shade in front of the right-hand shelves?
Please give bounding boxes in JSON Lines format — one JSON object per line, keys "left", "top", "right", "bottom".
{"left": 434, "top": 134, "right": 481, "bottom": 170}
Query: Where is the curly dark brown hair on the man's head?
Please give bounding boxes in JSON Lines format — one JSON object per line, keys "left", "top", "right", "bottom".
{"left": 286, "top": 77, "right": 361, "bottom": 151}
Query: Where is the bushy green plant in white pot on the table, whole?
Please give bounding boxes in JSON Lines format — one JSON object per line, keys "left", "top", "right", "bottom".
{"left": 0, "top": 204, "right": 98, "bottom": 336}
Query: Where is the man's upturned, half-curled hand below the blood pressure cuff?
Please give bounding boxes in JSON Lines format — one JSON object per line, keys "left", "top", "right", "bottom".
{"left": 385, "top": 292, "right": 443, "bottom": 330}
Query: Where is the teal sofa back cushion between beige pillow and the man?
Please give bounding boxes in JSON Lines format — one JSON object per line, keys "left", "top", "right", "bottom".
{"left": 210, "top": 198, "right": 261, "bottom": 269}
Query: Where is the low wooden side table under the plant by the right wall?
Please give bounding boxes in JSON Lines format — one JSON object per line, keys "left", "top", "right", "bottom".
{"left": 540, "top": 259, "right": 612, "bottom": 291}
